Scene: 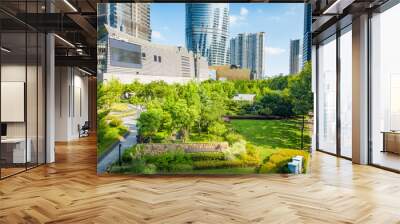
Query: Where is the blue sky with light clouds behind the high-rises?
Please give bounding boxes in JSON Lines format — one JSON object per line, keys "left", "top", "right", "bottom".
{"left": 151, "top": 3, "right": 304, "bottom": 76}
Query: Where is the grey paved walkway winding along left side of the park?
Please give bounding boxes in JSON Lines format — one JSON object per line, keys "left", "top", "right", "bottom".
{"left": 97, "top": 105, "right": 140, "bottom": 174}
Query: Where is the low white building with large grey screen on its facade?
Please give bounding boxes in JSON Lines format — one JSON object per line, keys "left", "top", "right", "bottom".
{"left": 102, "top": 26, "right": 209, "bottom": 83}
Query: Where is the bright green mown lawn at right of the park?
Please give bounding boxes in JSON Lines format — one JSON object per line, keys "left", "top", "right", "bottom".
{"left": 231, "top": 119, "right": 311, "bottom": 151}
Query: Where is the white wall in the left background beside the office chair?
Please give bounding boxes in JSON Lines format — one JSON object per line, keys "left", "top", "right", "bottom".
{"left": 55, "top": 67, "right": 89, "bottom": 141}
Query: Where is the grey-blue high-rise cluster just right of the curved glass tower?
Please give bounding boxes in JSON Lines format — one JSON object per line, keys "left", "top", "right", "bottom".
{"left": 230, "top": 32, "right": 265, "bottom": 79}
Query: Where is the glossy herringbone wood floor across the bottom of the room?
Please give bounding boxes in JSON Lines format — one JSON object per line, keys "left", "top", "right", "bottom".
{"left": 0, "top": 138, "right": 400, "bottom": 224}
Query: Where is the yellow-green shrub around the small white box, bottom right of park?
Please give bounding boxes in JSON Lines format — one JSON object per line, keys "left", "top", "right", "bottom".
{"left": 259, "top": 149, "right": 309, "bottom": 173}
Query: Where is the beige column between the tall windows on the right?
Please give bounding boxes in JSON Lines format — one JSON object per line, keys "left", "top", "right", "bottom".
{"left": 352, "top": 15, "right": 368, "bottom": 164}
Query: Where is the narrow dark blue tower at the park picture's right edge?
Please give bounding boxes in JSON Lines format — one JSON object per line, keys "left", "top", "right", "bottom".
{"left": 303, "top": 3, "right": 312, "bottom": 66}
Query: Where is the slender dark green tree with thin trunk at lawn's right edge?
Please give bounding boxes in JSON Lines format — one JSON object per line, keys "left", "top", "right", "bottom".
{"left": 288, "top": 62, "right": 313, "bottom": 149}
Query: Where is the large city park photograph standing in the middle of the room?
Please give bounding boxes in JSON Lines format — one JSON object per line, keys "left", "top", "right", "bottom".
{"left": 97, "top": 3, "right": 314, "bottom": 175}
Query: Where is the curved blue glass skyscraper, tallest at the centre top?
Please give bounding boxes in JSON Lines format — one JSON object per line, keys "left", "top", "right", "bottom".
{"left": 186, "top": 3, "right": 229, "bottom": 65}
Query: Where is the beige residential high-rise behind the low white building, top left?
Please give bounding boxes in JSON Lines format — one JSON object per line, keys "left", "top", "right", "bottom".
{"left": 98, "top": 3, "right": 151, "bottom": 41}
